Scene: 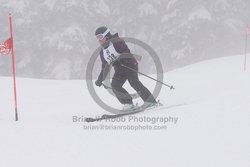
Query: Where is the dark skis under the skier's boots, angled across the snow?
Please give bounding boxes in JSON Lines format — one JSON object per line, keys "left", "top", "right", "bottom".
{"left": 85, "top": 100, "right": 163, "bottom": 122}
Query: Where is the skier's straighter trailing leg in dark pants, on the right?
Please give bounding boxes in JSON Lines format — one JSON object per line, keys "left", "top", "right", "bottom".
{"left": 127, "top": 65, "right": 156, "bottom": 103}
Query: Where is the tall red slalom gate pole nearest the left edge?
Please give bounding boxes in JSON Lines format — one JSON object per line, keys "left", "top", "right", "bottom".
{"left": 9, "top": 14, "right": 18, "bottom": 121}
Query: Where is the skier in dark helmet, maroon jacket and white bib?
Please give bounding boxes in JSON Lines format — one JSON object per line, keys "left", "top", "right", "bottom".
{"left": 95, "top": 26, "right": 157, "bottom": 111}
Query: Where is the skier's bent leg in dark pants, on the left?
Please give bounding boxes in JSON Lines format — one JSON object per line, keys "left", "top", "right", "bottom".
{"left": 111, "top": 72, "right": 133, "bottom": 104}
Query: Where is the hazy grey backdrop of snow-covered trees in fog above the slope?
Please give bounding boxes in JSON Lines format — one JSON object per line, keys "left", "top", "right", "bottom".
{"left": 0, "top": 0, "right": 250, "bottom": 79}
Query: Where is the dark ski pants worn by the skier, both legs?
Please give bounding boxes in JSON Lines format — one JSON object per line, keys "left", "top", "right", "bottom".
{"left": 111, "top": 64, "right": 155, "bottom": 104}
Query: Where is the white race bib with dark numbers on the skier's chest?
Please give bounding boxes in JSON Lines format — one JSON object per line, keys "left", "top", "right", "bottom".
{"left": 103, "top": 44, "right": 120, "bottom": 64}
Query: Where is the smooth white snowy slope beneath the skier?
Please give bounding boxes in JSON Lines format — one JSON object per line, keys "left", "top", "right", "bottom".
{"left": 0, "top": 56, "right": 250, "bottom": 167}
